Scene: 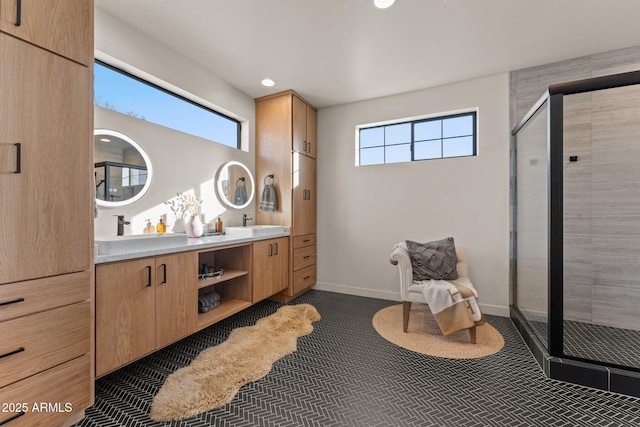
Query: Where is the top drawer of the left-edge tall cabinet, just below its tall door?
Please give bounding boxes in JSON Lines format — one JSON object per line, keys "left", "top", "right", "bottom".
{"left": 0, "top": 271, "right": 91, "bottom": 322}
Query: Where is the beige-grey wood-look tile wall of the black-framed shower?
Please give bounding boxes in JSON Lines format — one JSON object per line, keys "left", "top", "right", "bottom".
{"left": 510, "top": 46, "right": 640, "bottom": 329}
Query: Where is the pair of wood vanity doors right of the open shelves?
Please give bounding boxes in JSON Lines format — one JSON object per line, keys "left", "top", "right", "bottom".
{"left": 253, "top": 237, "right": 289, "bottom": 303}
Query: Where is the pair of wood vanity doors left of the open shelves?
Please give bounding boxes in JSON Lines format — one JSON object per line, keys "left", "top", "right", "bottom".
{"left": 96, "top": 252, "right": 197, "bottom": 376}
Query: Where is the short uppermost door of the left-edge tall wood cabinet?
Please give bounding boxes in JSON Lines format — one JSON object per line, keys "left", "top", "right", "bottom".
{"left": 0, "top": 0, "right": 93, "bottom": 66}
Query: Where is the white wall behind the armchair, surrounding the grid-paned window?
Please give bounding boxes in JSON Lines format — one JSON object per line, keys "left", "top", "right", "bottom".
{"left": 316, "top": 73, "right": 510, "bottom": 316}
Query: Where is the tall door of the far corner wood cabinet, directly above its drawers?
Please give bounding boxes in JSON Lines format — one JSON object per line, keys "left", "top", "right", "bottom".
{"left": 291, "top": 153, "right": 316, "bottom": 236}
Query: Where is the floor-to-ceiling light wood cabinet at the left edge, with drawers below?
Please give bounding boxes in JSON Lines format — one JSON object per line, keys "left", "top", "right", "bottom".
{"left": 0, "top": 0, "right": 93, "bottom": 426}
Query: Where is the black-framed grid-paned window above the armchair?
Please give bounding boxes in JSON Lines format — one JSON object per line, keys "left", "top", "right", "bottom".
{"left": 358, "top": 111, "right": 477, "bottom": 166}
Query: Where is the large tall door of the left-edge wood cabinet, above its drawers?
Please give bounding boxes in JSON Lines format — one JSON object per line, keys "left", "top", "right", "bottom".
{"left": 0, "top": 34, "right": 93, "bottom": 283}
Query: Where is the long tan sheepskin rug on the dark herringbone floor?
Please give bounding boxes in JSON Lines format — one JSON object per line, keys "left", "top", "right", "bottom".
{"left": 150, "top": 304, "right": 320, "bottom": 421}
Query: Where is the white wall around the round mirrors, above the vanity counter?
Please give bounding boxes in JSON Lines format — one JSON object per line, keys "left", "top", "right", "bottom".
{"left": 94, "top": 9, "right": 255, "bottom": 236}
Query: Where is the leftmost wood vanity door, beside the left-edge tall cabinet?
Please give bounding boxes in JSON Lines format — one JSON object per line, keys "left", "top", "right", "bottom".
{"left": 95, "top": 258, "right": 156, "bottom": 376}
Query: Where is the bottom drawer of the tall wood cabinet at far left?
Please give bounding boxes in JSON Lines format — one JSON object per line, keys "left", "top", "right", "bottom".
{"left": 0, "top": 355, "right": 93, "bottom": 427}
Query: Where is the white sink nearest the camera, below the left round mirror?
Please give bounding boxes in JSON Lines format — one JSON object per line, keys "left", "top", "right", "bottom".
{"left": 95, "top": 233, "right": 189, "bottom": 255}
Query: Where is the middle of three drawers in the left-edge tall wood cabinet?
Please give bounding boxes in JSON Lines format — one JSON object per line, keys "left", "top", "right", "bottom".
{"left": 0, "top": 302, "right": 91, "bottom": 387}
